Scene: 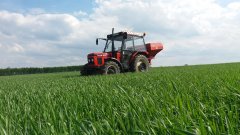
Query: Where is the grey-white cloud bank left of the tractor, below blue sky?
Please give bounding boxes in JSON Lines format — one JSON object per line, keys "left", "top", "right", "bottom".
{"left": 0, "top": 11, "right": 124, "bottom": 68}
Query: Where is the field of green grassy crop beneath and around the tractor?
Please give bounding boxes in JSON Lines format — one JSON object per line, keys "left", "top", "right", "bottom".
{"left": 0, "top": 63, "right": 240, "bottom": 135}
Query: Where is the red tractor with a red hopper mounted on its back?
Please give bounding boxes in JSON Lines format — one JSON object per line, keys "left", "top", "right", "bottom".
{"left": 80, "top": 28, "right": 163, "bottom": 75}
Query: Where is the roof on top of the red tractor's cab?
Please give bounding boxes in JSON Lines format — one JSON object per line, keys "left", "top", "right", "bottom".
{"left": 107, "top": 31, "right": 146, "bottom": 40}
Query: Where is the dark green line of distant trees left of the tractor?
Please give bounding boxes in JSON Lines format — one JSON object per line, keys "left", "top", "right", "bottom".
{"left": 0, "top": 66, "right": 81, "bottom": 76}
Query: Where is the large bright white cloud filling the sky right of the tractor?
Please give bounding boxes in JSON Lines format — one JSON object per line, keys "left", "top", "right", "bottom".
{"left": 93, "top": 0, "right": 240, "bottom": 66}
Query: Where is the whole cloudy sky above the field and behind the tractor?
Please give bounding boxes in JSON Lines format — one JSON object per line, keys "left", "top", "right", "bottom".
{"left": 0, "top": 0, "right": 240, "bottom": 68}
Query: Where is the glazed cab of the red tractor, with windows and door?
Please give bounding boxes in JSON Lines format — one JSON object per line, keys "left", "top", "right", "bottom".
{"left": 99, "top": 32, "right": 146, "bottom": 69}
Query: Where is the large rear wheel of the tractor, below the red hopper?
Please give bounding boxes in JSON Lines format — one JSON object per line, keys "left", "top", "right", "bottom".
{"left": 130, "top": 55, "right": 149, "bottom": 72}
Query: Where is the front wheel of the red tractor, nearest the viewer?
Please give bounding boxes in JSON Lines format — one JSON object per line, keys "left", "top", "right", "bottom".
{"left": 103, "top": 61, "right": 120, "bottom": 75}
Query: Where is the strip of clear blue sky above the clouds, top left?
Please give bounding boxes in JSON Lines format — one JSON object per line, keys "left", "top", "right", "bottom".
{"left": 0, "top": 0, "right": 95, "bottom": 13}
